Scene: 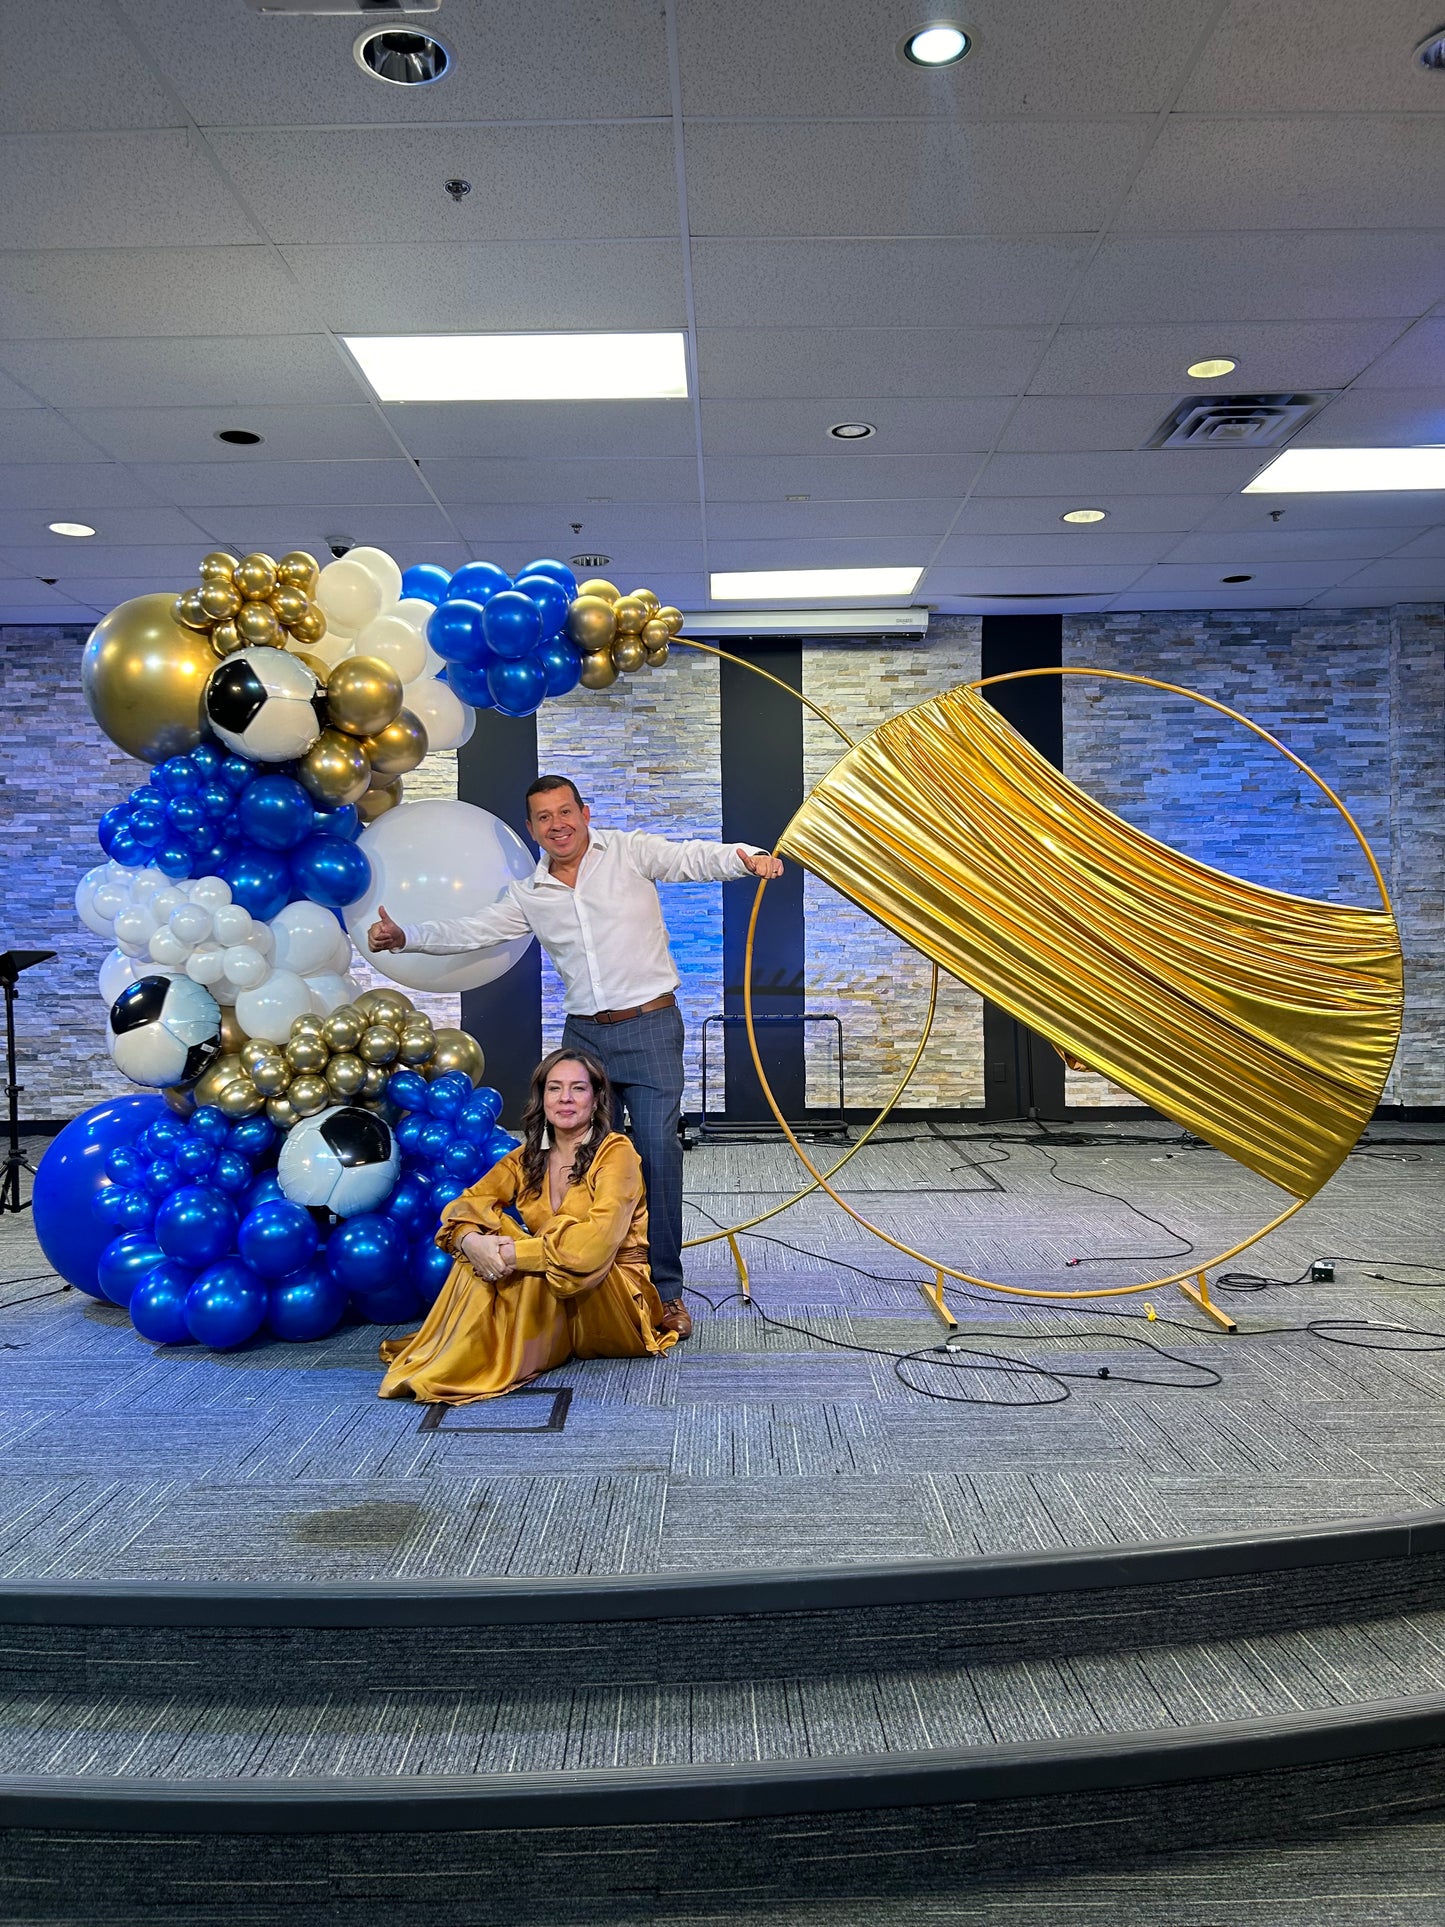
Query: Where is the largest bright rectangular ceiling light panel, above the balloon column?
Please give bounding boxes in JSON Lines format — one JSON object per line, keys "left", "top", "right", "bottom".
{"left": 341, "top": 333, "right": 688, "bottom": 401}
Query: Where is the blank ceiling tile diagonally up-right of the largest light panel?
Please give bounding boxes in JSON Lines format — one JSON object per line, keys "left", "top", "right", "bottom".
{"left": 692, "top": 235, "right": 1090, "bottom": 328}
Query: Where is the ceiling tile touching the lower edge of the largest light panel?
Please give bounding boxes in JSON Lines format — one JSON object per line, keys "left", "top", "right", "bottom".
{"left": 385, "top": 401, "right": 696, "bottom": 462}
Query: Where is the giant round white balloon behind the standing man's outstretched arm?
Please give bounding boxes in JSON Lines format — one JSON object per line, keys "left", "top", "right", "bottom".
{"left": 346, "top": 798, "right": 538, "bottom": 994}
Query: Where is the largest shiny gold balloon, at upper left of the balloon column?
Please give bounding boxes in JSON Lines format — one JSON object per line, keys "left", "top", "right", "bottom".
{"left": 81, "top": 594, "right": 216, "bottom": 763}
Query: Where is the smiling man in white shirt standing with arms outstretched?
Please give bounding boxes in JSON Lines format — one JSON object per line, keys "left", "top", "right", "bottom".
{"left": 368, "top": 777, "right": 782, "bottom": 1337}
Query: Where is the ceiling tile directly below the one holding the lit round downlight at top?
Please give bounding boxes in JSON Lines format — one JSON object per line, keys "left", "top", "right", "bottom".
{"left": 688, "top": 119, "right": 1148, "bottom": 237}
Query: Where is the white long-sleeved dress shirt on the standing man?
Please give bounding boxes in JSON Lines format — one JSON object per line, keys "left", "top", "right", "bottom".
{"left": 405, "top": 831, "right": 759, "bottom": 1017}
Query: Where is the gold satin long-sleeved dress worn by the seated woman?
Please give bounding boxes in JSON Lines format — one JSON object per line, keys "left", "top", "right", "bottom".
{"left": 378, "top": 1131, "right": 676, "bottom": 1405}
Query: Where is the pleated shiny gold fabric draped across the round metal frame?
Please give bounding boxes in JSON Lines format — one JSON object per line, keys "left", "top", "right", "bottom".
{"left": 778, "top": 688, "right": 1403, "bottom": 1197}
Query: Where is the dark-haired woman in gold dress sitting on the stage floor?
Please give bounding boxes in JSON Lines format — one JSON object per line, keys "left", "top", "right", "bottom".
{"left": 380, "top": 1050, "right": 676, "bottom": 1405}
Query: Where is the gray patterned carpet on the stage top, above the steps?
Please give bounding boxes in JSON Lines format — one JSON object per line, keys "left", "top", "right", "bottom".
{"left": 0, "top": 1125, "right": 1445, "bottom": 1580}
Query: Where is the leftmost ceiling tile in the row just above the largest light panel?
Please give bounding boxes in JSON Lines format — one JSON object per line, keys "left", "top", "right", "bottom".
{"left": 0, "top": 245, "right": 304, "bottom": 341}
